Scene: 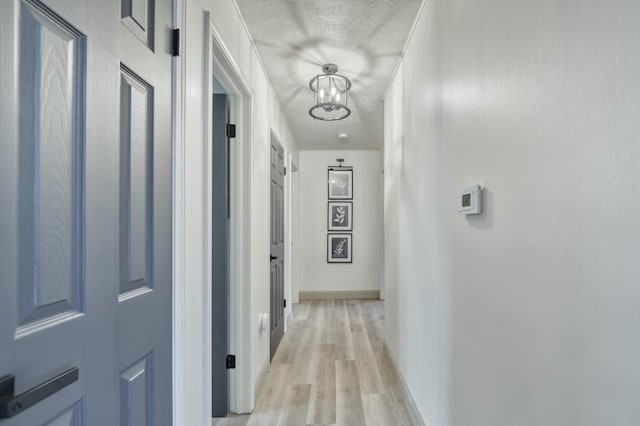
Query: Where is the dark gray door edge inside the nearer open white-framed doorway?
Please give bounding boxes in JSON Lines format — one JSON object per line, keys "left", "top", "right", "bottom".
{"left": 211, "top": 94, "right": 229, "bottom": 417}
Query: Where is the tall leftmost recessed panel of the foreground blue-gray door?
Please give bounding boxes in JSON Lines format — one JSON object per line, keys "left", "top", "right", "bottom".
{"left": 14, "top": 2, "right": 85, "bottom": 336}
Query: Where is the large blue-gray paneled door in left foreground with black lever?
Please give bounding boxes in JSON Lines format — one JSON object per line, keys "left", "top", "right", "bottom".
{"left": 0, "top": 0, "right": 172, "bottom": 426}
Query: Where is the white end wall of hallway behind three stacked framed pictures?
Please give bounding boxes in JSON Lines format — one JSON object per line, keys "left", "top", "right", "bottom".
{"left": 298, "top": 151, "right": 382, "bottom": 291}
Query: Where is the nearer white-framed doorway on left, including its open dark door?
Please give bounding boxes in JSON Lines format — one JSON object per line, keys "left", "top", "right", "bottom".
{"left": 203, "top": 13, "right": 254, "bottom": 417}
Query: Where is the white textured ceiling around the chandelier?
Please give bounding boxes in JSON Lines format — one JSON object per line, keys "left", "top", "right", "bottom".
{"left": 237, "top": 0, "right": 422, "bottom": 149}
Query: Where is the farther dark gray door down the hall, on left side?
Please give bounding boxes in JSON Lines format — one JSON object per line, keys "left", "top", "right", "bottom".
{"left": 269, "top": 140, "right": 284, "bottom": 358}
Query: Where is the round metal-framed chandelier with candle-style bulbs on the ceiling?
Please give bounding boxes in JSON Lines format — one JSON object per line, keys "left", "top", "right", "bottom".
{"left": 309, "top": 64, "right": 351, "bottom": 121}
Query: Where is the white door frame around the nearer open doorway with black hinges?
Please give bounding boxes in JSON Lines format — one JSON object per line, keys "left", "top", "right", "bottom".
{"left": 203, "top": 11, "right": 253, "bottom": 416}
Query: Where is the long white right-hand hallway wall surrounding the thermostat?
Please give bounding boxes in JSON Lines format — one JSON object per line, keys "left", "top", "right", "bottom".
{"left": 385, "top": 0, "right": 640, "bottom": 426}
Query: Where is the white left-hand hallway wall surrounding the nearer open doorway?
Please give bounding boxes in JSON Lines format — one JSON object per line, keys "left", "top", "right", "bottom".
{"left": 181, "top": 0, "right": 297, "bottom": 425}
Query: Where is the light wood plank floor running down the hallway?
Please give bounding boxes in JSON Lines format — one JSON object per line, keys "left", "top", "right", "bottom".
{"left": 212, "top": 300, "right": 411, "bottom": 426}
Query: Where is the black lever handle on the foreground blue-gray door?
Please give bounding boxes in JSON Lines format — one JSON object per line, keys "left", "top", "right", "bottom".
{"left": 0, "top": 367, "right": 80, "bottom": 419}
